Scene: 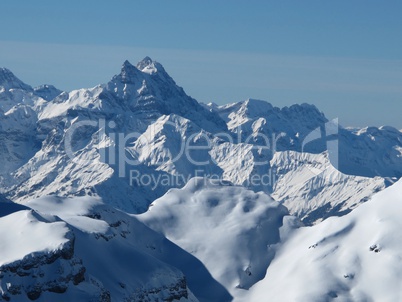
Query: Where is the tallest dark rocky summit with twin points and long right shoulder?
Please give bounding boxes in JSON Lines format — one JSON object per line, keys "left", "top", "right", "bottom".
{"left": 103, "top": 57, "right": 227, "bottom": 133}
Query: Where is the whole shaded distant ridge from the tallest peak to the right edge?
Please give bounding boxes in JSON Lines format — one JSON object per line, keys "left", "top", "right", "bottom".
{"left": 204, "top": 99, "right": 402, "bottom": 178}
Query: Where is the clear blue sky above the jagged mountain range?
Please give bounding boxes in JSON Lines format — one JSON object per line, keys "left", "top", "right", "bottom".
{"left": 0, "top": 0, "right": 402, "bottom": 129}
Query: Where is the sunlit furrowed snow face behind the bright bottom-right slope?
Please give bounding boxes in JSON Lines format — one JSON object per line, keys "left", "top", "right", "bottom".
{"left": 271, "top": 151, "right": 386, "bottom": 224}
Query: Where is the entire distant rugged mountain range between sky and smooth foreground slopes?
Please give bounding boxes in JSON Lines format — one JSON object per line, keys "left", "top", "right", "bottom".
{"left": 0, "top": 57, "right": 402, "bottom": 219}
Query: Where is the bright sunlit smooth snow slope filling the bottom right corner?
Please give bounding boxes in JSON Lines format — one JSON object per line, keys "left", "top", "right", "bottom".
{"left": 243, "top": 181, "right": 402, "bottom": 302}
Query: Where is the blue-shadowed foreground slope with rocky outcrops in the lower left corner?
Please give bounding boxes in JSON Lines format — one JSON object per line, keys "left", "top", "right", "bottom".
{"left": 0, "top": 197, "right": 231, "bottom": 301}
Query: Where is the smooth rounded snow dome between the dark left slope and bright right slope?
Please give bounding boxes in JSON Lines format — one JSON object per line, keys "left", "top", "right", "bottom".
{"left": 138, "top": 178, "right": 296, "bottom": 296}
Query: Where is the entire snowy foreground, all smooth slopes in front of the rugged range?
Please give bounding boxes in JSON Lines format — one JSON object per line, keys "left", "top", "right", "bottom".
{"left": 0, "top": 179, "right": 402, "bottom": 302}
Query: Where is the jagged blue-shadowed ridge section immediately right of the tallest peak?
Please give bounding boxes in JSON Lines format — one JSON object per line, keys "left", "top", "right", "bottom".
{"left": 206, "top": 99, "right": 328, "bottom": 152}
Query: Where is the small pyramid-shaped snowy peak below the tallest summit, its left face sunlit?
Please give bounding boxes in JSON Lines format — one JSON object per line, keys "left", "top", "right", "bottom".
{"left": 132, "top": 114, "right": 221, "bottom": 178}
